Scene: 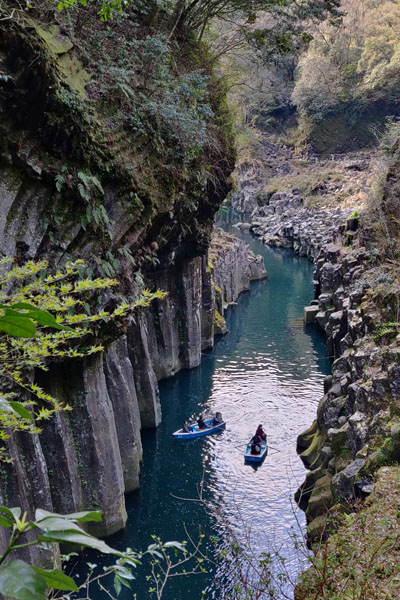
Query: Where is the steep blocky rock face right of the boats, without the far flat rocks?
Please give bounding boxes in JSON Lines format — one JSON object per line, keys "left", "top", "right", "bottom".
{"left": 296, "top": 241, "right": 400, "bottom": 540}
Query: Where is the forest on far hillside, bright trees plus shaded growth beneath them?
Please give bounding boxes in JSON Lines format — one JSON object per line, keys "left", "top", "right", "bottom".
{"left": 228, "top": 1, "right": 399, "bottom": 153}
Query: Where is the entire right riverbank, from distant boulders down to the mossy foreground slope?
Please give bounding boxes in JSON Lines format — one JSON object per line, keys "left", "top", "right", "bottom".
{"left": 233, "top": 135, "right": 400, "bottom": 599}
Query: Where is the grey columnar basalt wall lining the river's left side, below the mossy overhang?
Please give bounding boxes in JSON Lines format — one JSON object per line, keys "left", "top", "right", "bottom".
{"left": 0, "top": 234, "right": 266, "bottom": 561}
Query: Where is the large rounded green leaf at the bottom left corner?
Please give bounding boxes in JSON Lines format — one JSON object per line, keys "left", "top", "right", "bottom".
{"left": 0, "top": 560, "right": 47, "bottom": 600}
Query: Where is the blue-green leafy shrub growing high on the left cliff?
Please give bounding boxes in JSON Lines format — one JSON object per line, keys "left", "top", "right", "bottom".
{"left": 89, "top": 32, "right": 213, "bottom": 160}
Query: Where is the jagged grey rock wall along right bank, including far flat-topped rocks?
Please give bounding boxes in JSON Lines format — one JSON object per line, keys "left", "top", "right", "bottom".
{"left": 230, "top": 155, "right": 400, "bottom": 541}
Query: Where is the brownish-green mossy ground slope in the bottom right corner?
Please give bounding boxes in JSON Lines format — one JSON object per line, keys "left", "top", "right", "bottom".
{"left": 295, "top": 467, "right": 400, "bottom": 600}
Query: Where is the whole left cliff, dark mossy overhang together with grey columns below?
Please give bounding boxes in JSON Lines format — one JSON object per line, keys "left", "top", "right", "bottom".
{"left": 0, "top": 2, "right": 265, "bottom": 560}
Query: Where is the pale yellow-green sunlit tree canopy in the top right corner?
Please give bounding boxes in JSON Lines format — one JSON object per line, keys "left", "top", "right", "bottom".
{"left": 292, "top": 0, "right": 400, "bottom": 118}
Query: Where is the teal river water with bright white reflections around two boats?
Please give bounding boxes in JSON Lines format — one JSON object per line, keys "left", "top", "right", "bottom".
{"left": 83, "top": 229, "right": 331, "bottom": 600}
